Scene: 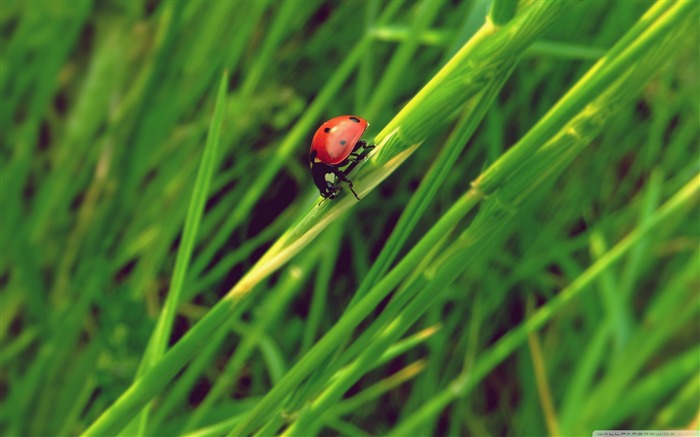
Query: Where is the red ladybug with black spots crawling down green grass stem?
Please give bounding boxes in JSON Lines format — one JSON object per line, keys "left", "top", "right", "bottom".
{"left": 309, "top": 115, "right": 375, "bottom": 200}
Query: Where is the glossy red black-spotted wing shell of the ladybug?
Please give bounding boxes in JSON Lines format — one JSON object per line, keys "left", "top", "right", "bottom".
{"left": 310, "top": 115, "right": 369, "bottom": 165}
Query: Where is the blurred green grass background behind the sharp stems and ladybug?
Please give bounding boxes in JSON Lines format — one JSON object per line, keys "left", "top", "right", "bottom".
{"left": 0, "top": 0, "right": 700, "bottom": 435}
